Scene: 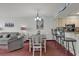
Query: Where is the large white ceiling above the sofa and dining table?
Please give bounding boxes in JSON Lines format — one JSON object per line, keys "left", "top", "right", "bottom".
{"left": 0, "top": 3, "right": 65, "bottom": 17}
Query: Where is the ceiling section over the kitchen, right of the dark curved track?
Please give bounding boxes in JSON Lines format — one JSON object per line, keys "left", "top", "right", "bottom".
{"left": 58, "top": 3, "right": 79, "bottom": 18}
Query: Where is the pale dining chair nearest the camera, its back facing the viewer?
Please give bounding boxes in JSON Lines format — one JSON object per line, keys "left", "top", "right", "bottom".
{"left": 32, "top": 35, "right": 42, "bottom": 56}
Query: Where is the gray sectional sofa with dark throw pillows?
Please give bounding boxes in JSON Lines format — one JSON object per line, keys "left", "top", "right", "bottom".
{"left": 0, "top": 32, "right": 24, "bottom": 51}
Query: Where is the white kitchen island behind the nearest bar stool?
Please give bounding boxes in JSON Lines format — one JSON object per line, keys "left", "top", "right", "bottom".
{"left": 65, "top": 32, "right": 79, "bottom": 56}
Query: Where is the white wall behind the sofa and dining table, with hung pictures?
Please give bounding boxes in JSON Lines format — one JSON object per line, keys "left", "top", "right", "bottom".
{"left": 0, "top": 17, "right": 56, "bottom": 40}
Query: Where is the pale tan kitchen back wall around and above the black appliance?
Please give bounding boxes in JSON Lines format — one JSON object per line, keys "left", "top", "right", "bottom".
{"left": 58, "top": 16, "right": 79, "bottom": 27}
